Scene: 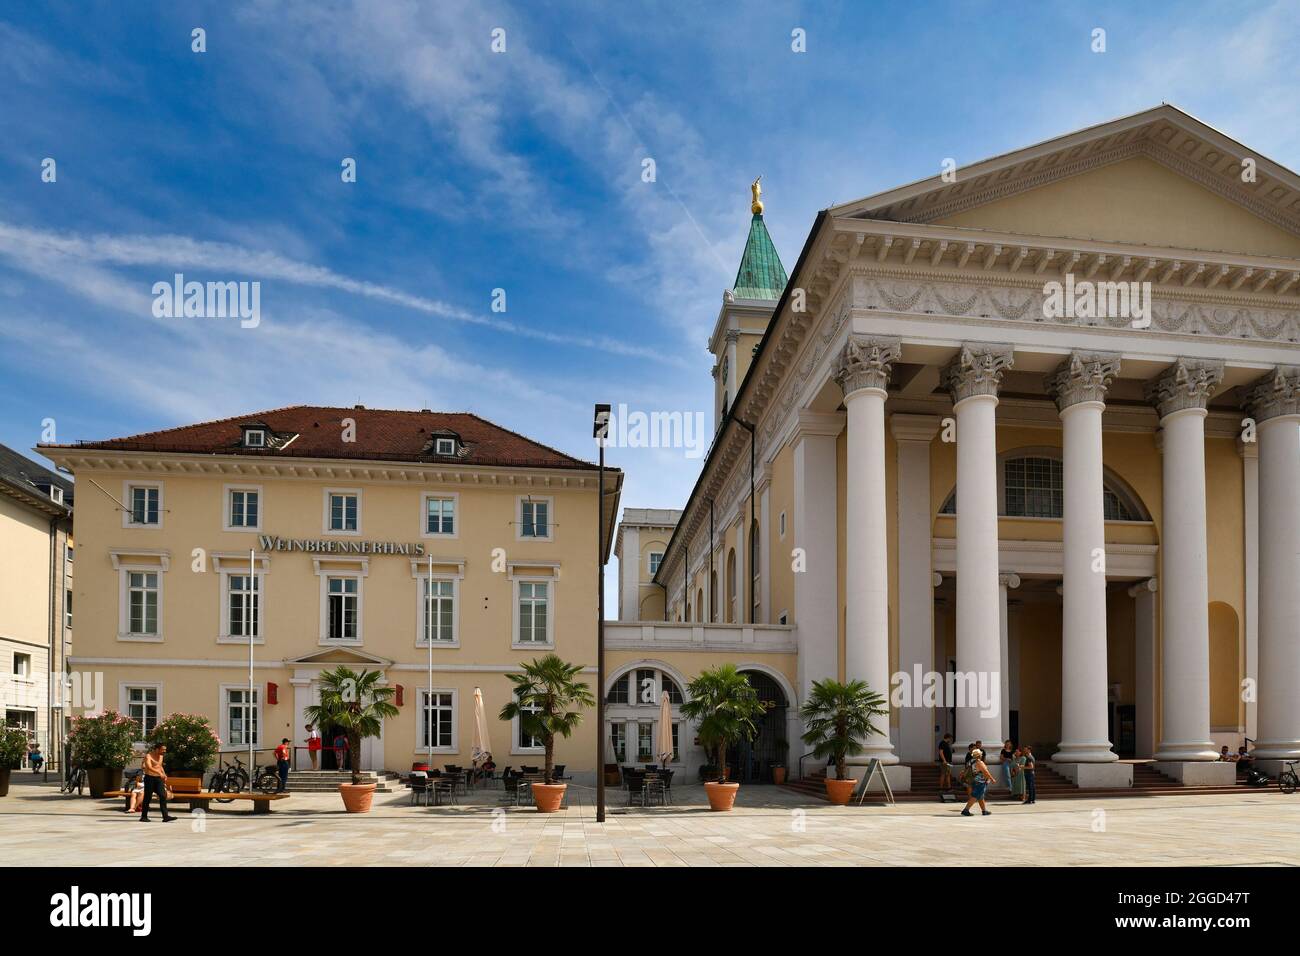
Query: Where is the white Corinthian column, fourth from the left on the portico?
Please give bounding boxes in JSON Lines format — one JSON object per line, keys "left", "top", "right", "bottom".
{"left": 1147, "top": 359, "right": 1223, "bottom": 762}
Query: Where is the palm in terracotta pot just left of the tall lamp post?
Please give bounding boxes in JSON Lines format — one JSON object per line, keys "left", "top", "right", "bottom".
{"left": 501, "top": 654, "right": 595, "bottom": 813}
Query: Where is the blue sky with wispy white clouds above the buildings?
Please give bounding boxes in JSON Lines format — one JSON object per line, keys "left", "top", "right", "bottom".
{"left": 0, "top": 0, "right": 1300, "bottom": 598}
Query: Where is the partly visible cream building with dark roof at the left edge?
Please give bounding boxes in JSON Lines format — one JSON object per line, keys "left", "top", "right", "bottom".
{"left": 0, "top": 445, "right": 73, "bottom": 770}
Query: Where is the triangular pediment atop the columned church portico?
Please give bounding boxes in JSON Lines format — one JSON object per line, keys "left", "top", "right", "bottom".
{"left": 831, "top": 105, "right": 1300, "bottom": 258}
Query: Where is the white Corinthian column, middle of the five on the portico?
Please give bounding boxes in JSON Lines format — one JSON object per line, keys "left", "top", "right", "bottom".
{"left": 1047, "top": 352, "right": 1119, "bottom": 763}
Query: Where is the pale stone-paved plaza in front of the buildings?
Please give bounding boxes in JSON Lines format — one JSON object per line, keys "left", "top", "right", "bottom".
{"left": 0, "top": 774, "right": 1300, "bottom": 866}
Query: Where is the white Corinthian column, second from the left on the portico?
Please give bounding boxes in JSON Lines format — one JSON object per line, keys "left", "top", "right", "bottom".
{"left": 943, "top": 345, "right": 1013, "bottom": 761}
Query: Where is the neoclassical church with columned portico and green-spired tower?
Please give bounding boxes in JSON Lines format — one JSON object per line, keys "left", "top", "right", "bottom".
{"left": 615, "top": 105, "right": 1300, "bottom": 787}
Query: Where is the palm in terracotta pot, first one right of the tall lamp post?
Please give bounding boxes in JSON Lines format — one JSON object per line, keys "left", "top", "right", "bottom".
{"left": 681, "top": 663, "right": 764, "bottom": 810}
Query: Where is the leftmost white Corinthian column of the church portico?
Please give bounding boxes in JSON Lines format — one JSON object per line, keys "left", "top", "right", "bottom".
{"left": 835, "top": 337, "right": 901, "bottom": 763}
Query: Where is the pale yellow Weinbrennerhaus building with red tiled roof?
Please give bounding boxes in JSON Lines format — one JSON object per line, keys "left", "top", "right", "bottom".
{"left": 42, "top": 406, "right": 621, "bottom": 779}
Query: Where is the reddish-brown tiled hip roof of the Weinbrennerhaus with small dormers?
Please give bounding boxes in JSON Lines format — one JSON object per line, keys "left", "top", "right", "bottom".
{"left": 48, "top": 405, "right": 603, "bottom": 471}
